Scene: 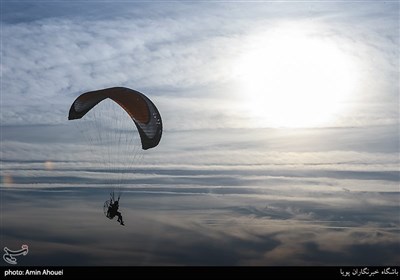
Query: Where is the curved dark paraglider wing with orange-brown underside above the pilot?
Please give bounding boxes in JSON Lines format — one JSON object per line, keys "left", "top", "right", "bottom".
{"left": 68, "top": 87, "right": 162, "bottom": 150}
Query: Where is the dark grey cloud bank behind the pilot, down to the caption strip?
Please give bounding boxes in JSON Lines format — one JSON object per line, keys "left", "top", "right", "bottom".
{"left": 2, "top": 186, "right": 399, "bottom": 265}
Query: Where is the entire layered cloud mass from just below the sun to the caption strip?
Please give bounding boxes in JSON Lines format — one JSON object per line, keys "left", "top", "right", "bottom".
{"left": 1, "top": 126, "right": 399, "bottom": 265}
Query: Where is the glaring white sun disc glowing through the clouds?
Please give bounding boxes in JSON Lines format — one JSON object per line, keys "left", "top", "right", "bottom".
{"left": 235, "top": 26, "right": 357, "bottom": 127}
